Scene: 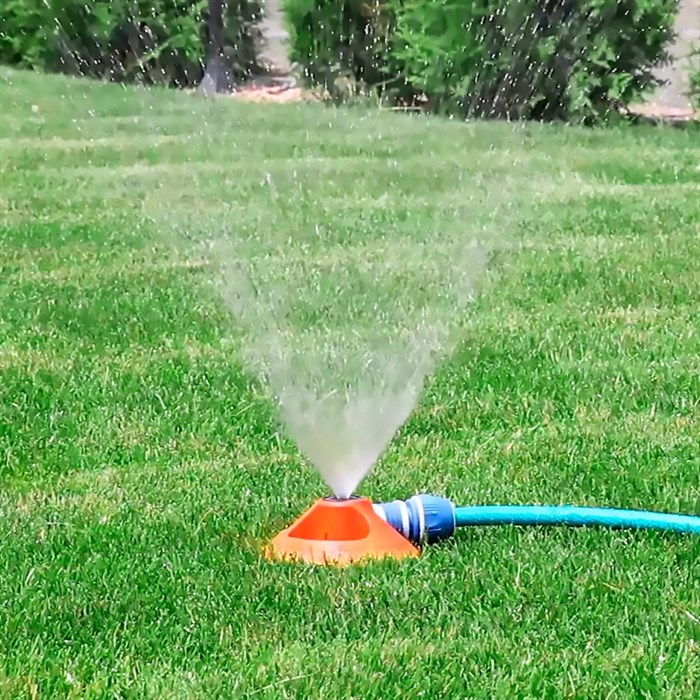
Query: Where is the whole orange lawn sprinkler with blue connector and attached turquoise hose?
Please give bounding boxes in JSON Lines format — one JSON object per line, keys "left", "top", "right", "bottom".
{"left": 266, "top": 494, "right": 700, "bottom": 564}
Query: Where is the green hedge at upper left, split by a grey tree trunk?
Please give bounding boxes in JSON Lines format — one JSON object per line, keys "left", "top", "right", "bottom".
{"left": 0, "top": 0, "right": 260, "bottom": 86}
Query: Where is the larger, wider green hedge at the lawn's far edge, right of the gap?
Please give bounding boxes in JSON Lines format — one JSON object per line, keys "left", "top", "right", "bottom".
{"left": 286, "top": 0, "right": 677, "bottom": 121}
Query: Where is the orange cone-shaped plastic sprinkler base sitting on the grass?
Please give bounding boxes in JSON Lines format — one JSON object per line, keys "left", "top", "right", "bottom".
{"left": 266, "top": 498, "right": 419, "bottom": 564}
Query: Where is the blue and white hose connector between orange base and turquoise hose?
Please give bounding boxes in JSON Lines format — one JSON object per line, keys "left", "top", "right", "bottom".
{"left": 373, "top": 493, "right": 457, "bottom": 544}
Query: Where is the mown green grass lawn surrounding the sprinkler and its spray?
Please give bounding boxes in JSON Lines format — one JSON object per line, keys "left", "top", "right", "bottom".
{"left": 0, "top": 71, "right": 700, "bottom": 700}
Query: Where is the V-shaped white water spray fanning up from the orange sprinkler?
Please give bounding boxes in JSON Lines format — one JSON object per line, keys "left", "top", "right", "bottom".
{"left": 210, "top": 224, "right": 487, "bottom": 498}
